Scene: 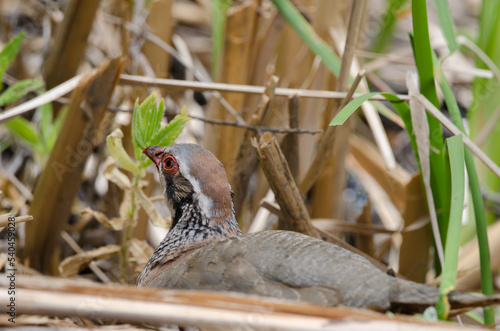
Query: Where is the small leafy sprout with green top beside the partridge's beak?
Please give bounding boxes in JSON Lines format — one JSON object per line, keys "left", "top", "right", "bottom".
{"left": 104, "top": 92, "right": 189, "bottom": 281}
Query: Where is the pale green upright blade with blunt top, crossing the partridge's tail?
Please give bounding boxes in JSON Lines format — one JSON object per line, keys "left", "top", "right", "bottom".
{"left": 436, "top": 135, "right": 466, "bottom": 319}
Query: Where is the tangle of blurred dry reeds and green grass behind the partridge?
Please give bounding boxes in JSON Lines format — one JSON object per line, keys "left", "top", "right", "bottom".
{"left": 0, "top": 0, "right": 500, "bottom": 324}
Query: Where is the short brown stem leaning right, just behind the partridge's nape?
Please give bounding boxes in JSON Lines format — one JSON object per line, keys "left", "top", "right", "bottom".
{"left": 229, "top": 76, "right": 278, "bottom": 215}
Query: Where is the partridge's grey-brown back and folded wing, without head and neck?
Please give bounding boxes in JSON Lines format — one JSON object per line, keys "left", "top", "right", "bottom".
{"left": 144, "top": 231, "right": 437, "bottom": 311}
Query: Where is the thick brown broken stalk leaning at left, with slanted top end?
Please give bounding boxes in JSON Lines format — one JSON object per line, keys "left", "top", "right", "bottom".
{"left": 24, "top": 58, "right": 123, "bottom": 274}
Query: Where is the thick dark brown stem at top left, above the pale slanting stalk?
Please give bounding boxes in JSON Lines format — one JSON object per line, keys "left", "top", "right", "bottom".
{"left": 44, "top": 0, "right": 101, "bottom": 111}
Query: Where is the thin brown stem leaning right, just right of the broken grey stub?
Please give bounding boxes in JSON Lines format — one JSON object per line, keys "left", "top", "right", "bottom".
{"left": 299, "top": 71, "right": 364, "bottom": 194}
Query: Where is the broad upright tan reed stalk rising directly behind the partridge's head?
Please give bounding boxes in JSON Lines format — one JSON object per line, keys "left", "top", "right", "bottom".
{"left": 204, "top": 0, "right": 257, "bottom": 174}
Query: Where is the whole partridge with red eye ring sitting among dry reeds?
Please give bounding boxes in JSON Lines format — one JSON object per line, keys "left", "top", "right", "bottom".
{"left": 137, "top": 144, "right": 500, "bottom": 312}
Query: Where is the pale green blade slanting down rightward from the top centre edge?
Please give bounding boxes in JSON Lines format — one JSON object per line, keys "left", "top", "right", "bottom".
{"left": 271, "top": 0, "right": 341, "bottom": 77}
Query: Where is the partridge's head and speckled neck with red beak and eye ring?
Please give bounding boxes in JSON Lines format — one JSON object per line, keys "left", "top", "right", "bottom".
{"left": 137, "top": 144, "right": 241, "bottom": 286}
